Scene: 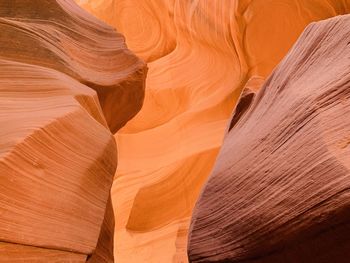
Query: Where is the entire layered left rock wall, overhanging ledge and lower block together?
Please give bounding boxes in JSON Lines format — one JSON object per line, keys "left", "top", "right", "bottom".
{"left": 0, "top": 0, "right": 145, "bottom": 263}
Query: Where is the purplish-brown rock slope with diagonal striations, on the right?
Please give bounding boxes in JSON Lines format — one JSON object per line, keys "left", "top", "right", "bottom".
{"left": 188, "top": 15, "right": 350, "bottom": 263}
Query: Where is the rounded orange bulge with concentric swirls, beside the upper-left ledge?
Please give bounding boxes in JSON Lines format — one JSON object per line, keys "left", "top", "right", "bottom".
{"left": 76, "top": 0, "right": 176, "bottom": 62}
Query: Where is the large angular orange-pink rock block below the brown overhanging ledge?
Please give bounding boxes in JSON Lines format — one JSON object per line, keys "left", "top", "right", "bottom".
{"left": 0, "top": 60, "right": 117, "bottom": 254}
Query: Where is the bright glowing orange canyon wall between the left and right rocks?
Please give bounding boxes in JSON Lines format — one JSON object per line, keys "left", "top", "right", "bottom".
{"left": 77, "top": 0, "right": 350, "bottom": 263}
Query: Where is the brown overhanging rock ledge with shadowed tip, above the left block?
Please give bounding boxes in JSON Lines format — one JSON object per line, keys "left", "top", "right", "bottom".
{"left": 0, "top": 0, "right": 146, "bottom": 133}
